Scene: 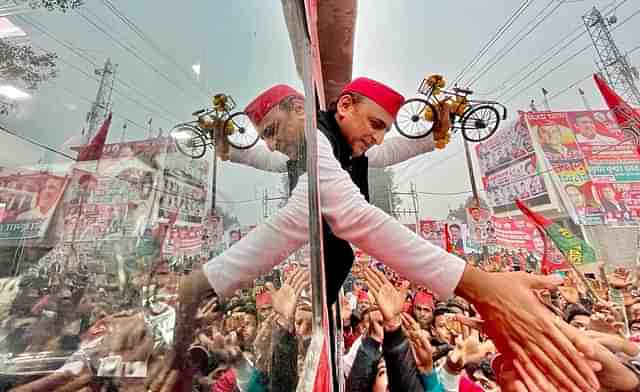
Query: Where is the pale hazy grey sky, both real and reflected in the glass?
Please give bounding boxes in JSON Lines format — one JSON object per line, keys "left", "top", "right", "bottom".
{"left": 0, "top": 0, "right": 640, "bottom": 223}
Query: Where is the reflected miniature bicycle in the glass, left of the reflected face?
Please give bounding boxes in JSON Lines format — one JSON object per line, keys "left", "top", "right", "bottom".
{"left": 171, "top": 94, "right": 259, "bottom": 159}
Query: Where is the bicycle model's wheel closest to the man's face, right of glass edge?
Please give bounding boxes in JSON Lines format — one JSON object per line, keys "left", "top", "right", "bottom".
{"left": 394, "top": 98, "right": 438, "bottom": 139}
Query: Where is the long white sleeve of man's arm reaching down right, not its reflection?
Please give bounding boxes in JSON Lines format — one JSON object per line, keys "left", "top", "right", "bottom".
{"left": 318, "top": 134, "right": 465, "bottom": 298}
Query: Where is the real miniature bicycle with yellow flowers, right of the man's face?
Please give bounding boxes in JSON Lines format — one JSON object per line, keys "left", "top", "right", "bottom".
{"left": 395, "top": 75, "right": 507, "bottom": 148}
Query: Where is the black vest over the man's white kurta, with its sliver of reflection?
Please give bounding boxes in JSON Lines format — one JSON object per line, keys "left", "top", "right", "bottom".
{"left": 287, "top": 112, "right": 369, "bottom": 306}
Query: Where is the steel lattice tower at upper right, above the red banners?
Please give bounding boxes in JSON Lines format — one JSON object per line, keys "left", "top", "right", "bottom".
{"left": 582, "top": 7, "right": 640, "bottom": 105}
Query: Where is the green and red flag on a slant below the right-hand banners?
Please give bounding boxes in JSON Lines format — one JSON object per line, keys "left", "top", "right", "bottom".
{"left": 516, "top": 199, "right": 597, "bottom": 272}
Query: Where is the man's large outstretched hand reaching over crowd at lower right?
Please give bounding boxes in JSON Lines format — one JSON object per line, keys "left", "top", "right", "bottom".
{"left": 457, "top": 266, "right": 599, "bottom": 392}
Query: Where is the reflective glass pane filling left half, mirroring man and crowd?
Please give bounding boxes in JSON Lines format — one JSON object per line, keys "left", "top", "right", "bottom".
{"left": 0, "top": 0, "right": 315, "bottom": 391}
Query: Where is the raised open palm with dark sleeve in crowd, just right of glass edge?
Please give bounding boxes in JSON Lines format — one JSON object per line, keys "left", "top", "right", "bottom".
{"left": 364, "top": 268, "right": 409, "bottom": 330}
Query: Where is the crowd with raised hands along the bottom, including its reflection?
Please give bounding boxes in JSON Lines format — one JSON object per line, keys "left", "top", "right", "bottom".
{"left": 1, "top": 250, "right": 640, "bottom": 392}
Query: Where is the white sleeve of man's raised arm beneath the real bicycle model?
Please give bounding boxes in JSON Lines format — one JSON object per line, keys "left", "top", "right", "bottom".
{"left": 366, "top": 133, "right": 434, "bottom": 167}
